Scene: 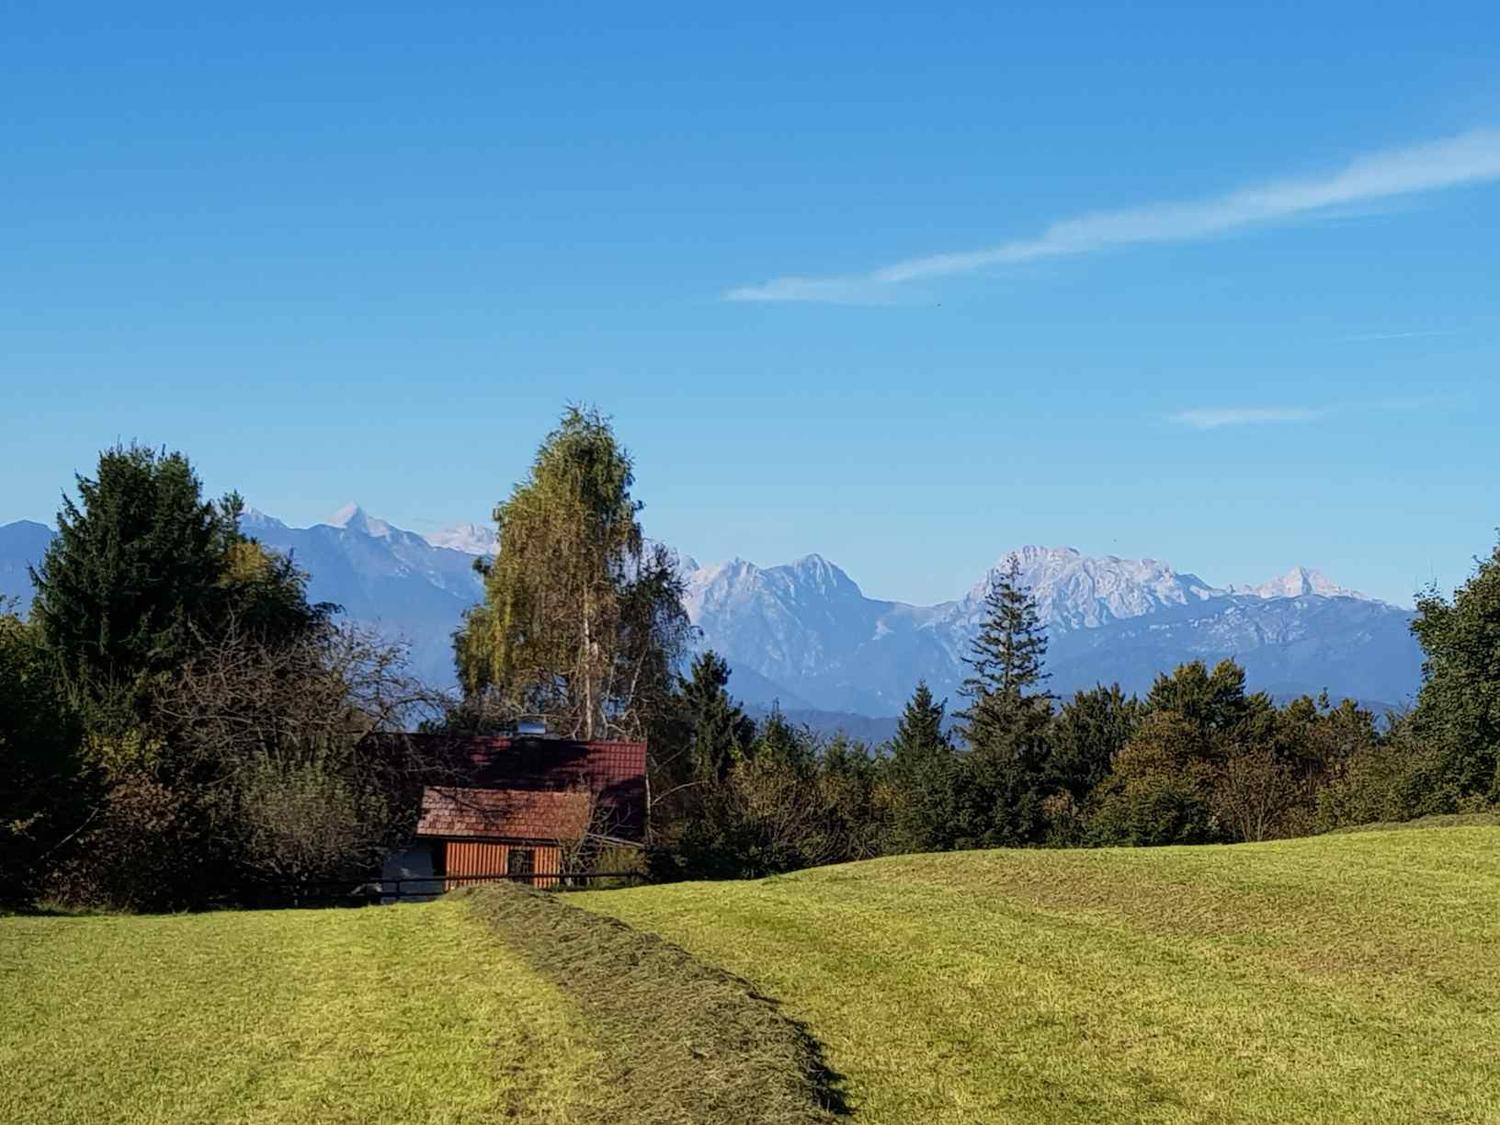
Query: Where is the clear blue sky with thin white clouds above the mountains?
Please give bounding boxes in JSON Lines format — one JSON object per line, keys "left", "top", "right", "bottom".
{"left": 0, "top": 3, "right": 1500, "bottom": 600}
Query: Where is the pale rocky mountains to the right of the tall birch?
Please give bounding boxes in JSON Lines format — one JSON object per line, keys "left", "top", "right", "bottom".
{"left": 687, "top": 546, "right": 1421, "bottom": 716}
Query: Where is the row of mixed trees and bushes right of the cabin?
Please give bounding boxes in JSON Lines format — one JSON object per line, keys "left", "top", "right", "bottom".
{"left": 654, "top": 561, "right": 1500, "bottom": 878}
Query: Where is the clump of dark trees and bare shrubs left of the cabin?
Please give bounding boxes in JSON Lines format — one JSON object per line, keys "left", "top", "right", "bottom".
{"left": 0, "top": 446, "right": 441, "bottom": 909}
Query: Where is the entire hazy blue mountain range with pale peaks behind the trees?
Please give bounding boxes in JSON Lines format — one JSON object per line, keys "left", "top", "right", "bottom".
{"left": 0, "top": 504, "right": 1421, "bottom": 716}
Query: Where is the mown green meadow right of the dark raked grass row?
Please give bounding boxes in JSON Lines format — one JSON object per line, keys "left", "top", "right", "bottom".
{"left": 570, "top": 827, "right": 1500, "bottom": 1125}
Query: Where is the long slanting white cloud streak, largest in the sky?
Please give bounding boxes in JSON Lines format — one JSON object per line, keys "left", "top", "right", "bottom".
{"left": 725, "top": 129, "right": 1500, "bottom": 303}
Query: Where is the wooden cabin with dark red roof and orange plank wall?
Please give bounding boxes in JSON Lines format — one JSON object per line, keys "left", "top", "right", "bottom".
{"left": 386, "top": 735, "right": 647, "bottom": 894}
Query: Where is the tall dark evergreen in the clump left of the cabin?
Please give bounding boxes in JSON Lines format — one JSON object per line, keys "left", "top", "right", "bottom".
{"left": 32, "top": 446, "right": 332, "bottom": 908}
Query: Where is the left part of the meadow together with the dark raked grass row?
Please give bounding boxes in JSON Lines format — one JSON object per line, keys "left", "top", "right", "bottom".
{"left": 0, "top": 888, "right": 837, "bottom": 1125}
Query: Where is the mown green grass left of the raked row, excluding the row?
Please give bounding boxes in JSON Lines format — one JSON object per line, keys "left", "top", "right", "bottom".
{"left": 0, "top": 900, "right": 605, "bottom": 1125}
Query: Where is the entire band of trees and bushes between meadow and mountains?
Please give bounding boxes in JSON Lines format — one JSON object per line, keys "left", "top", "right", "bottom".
{"left": 0, "top": 408, "right": 1500, "bottom": 909}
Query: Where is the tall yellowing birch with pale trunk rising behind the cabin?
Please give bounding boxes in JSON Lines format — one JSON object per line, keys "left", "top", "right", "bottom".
{"left": 455, "top": 407, "right": 692, "bottom": 740}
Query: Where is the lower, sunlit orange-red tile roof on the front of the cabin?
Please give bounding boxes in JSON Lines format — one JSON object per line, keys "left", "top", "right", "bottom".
{"left": 417, "top": 786, "right": 594, "bottom": 840}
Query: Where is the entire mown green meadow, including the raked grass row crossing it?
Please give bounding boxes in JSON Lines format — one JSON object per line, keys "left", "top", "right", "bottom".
{"left": 0, "top": 825, "right": 1500, "bottom": 1125}
